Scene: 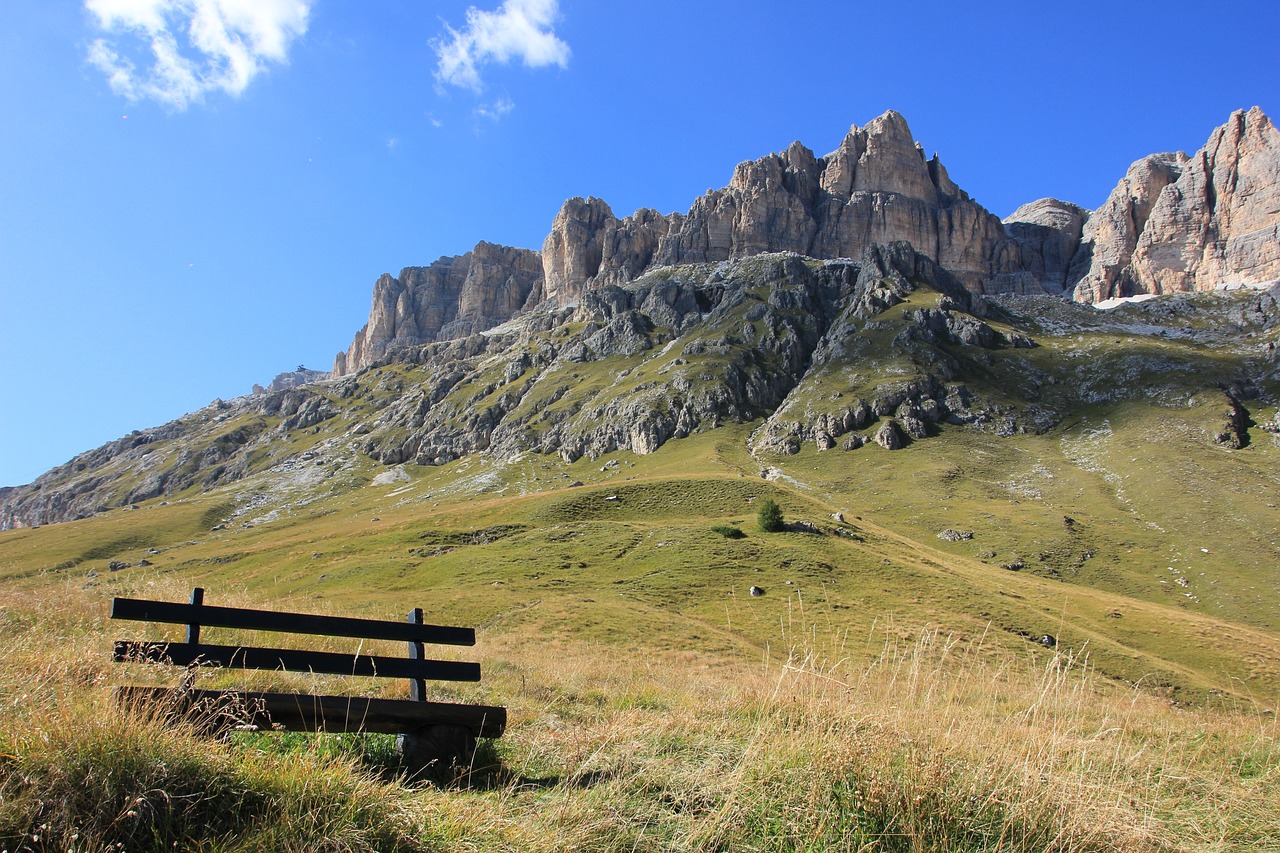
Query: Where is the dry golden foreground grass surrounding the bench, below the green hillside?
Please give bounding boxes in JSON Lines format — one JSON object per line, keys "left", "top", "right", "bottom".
{"left": 0, "top": 573, "right": 1280, "bottom": 853}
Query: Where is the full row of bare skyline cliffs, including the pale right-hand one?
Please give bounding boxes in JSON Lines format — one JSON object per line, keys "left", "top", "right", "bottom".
{"left": 334, "top": 108, "right": 1280, "bottom": 375}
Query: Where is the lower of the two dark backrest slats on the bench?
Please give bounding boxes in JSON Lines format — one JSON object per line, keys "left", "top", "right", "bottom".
{"left": 114, "top": 640, "right": 480, "bottom": 681}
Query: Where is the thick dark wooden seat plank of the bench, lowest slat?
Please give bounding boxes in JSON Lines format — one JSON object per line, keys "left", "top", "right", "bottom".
{"left": 116, "top": 686, "right": 507, "bottom": 738}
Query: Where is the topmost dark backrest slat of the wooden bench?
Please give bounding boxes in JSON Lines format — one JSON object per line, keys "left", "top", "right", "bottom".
{"left": 111, "top": 598, "right": 476, "bottom": 646}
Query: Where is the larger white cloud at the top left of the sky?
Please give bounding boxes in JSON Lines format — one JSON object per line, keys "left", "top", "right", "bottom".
{"left": 84, "top": 0, "right": 314, "bottom": 110}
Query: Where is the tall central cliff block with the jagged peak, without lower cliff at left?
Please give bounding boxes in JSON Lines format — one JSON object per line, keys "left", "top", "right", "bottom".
{"left": 555, "top": 111, "right": 1034, "bottom": 295}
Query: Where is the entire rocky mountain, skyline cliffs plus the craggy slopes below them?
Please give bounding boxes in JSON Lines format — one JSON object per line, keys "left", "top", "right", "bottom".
{"left": 0, "top": 110, "right": 1280, "bottom": 528}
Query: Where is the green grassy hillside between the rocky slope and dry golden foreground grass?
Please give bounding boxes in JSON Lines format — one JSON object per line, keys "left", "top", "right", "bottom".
{"left": 0, "top": 407, "right": 1280, "bottom": 706}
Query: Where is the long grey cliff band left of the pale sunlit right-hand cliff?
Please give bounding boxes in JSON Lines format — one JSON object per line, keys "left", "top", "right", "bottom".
{"left": 334, "top": 111, "right": 1078, "bottom": 375}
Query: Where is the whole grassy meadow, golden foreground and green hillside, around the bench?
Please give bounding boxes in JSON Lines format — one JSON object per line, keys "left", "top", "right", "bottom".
{"left": 0, "top": 420, "right": 1280, "bottom": 853}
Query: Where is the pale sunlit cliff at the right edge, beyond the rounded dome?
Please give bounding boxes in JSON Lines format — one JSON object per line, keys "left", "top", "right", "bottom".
{"left": 1071, "top": 108, "right": 1280, "bottom": 302}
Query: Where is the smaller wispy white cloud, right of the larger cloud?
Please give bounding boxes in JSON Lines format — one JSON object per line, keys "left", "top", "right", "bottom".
{"left": 431, "top": 0, "right": 570, "bottom": 92}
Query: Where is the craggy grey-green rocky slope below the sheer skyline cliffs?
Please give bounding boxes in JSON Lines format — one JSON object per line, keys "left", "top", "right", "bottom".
{"left": 10, "top": 242, "right": 1280, "bottom": 528}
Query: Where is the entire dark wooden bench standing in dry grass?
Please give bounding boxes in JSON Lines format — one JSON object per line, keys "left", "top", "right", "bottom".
{"left": 111, "top": 588, "right": 507, "bottom": 772}
